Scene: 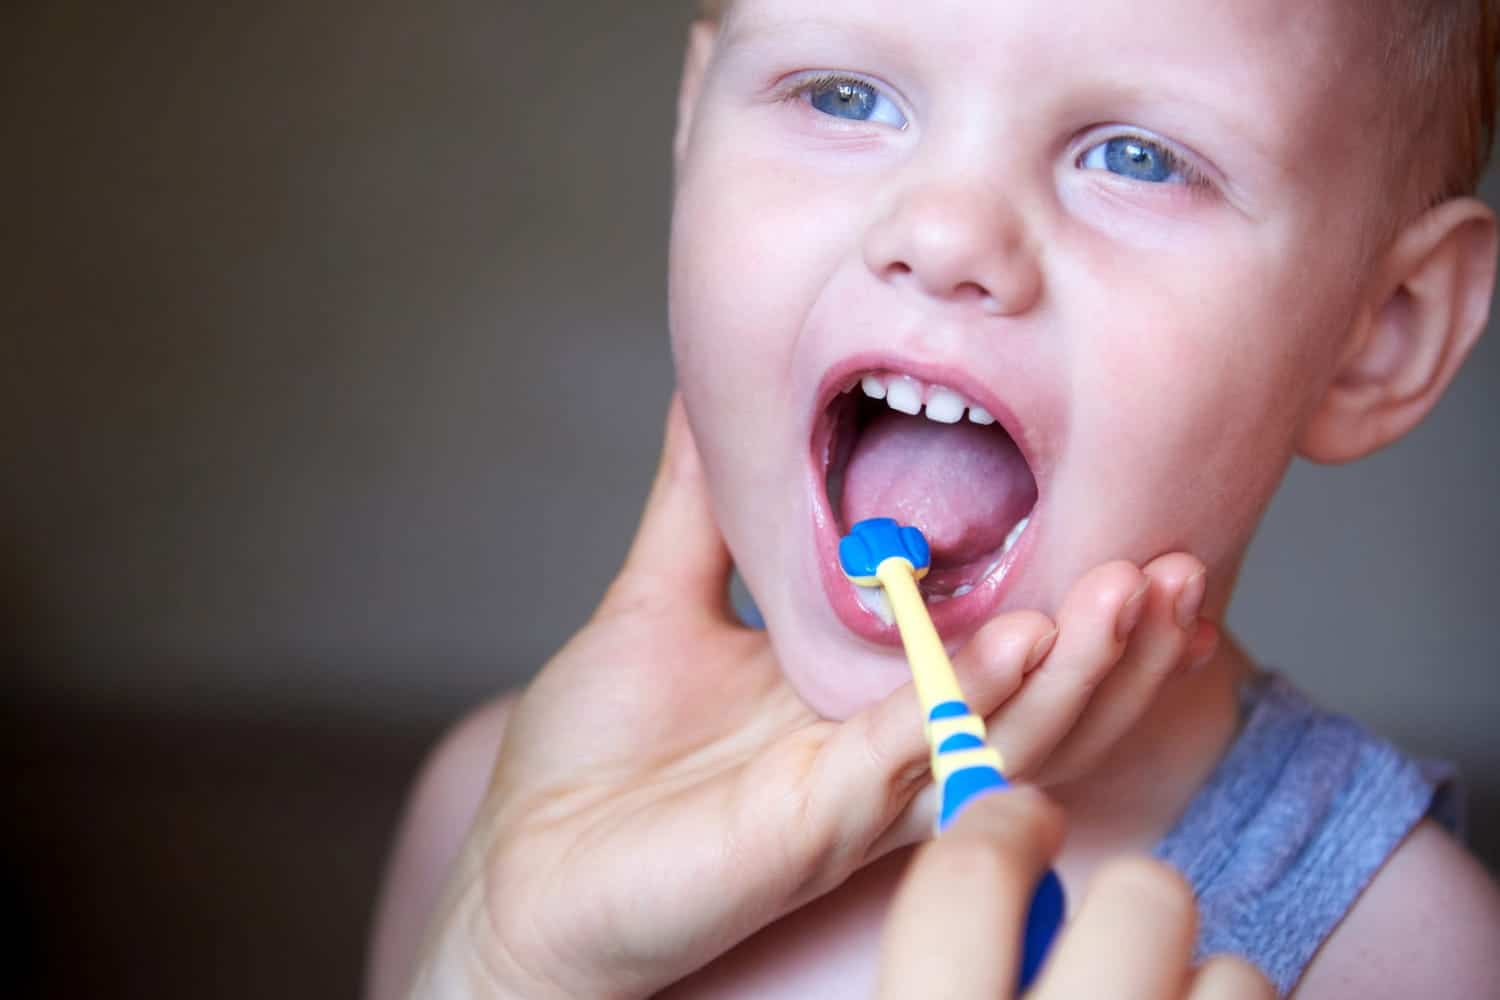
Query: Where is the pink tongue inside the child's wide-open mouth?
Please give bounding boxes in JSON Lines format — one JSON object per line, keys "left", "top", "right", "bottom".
{"left": 842, "top": 409, "right": 1037, "bottom": 564}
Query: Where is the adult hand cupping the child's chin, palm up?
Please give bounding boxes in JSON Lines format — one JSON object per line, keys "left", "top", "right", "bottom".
{"left": 417, "top": 402, "right": 1211, "bottom": 997}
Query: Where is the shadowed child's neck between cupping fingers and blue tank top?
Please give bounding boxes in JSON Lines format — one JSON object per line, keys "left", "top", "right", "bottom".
{"left": 1049, "top": 634, "right": 1254, "bottom": 888}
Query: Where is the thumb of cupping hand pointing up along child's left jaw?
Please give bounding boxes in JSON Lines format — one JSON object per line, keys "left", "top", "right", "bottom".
{"left": 600, "top": 394, "right": 732, "bottom": 621}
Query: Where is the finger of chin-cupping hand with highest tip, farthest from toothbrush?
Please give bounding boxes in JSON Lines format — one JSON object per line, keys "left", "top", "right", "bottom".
{"left": 1043, "top": 552, "right": 1206, "bottom": 781}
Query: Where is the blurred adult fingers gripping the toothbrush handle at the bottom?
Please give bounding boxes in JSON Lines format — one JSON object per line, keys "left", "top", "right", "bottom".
{"left": 879, "top": 787, "right": 1275, "bottom": 1000}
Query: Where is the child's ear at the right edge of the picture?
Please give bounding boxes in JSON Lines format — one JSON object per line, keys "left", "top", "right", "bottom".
{"left": 1298, "top": 198, "right": 1497, "bottom": 463}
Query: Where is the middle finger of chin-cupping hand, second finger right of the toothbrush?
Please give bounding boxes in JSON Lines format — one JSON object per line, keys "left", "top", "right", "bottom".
{"left": 990, "top": 562, "right": 1151, "bottom": 777}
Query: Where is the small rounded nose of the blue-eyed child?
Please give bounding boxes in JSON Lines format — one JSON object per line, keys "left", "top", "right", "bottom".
{"left": 864, "top": 186, "right": 1043, "bottom": 316}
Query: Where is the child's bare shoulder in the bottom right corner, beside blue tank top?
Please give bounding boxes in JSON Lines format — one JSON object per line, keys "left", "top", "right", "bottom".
{"left": 1295, "top": 820, "right": 1500, "bottom": 1000}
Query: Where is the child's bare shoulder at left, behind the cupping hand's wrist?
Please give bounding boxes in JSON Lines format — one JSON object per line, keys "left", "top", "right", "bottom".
{"left": 365, "top": 694, "right": 516, "bottom": 1000}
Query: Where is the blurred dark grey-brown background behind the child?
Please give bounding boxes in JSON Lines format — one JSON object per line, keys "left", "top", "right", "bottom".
{"left": 0, "top": 0, "right": 1500, "bottom": 997}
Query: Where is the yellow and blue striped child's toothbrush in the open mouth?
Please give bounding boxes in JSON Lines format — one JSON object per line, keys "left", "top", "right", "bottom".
{"left": 839, "top": 517, "right": 1067, "bottom": 990}
